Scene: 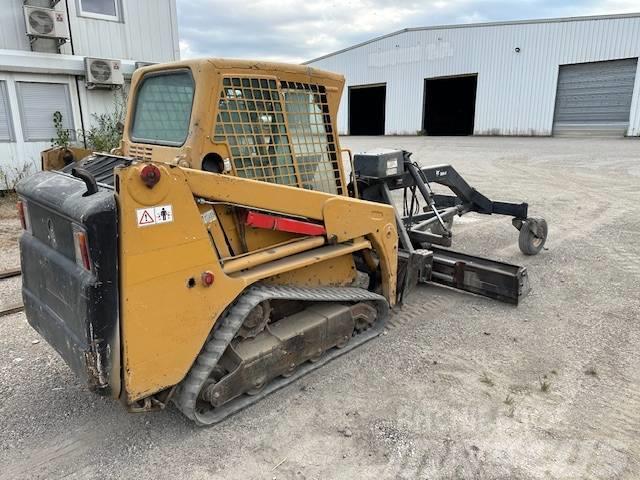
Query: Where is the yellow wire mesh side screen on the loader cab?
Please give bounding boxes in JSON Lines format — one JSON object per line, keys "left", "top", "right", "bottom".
{"left": 214, "top": 76, "right": 343, "bottom": 194}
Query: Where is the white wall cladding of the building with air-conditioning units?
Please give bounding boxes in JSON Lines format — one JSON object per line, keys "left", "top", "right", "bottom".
{"left": 0, "top": 0, "right": 180, "bottom": 186}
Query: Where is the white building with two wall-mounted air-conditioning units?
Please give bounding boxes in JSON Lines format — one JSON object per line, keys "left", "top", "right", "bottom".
{"left": 0, "top": 0, "right": 179, "bottom": 186}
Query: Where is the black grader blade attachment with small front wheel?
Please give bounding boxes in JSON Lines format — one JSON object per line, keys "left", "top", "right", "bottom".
{"left": 353, "top": 150, "right": 547, "bottom": 305}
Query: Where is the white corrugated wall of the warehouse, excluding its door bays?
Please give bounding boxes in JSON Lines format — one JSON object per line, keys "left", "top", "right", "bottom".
{"left": 309, "top": 15, "right": 640, "bottom": 135}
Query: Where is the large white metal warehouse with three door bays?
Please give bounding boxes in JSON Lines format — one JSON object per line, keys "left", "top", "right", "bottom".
{"left": 307, "top": 13, "right": 640, "bottom": 136}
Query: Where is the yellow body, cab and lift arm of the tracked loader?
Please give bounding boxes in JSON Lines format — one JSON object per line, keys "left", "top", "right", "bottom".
{"left": 114, "top": 59, "right": 398, "bottom": 404}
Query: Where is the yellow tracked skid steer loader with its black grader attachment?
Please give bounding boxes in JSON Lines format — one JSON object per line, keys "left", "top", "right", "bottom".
{"left": 17, "top": 59, "right": 547, "bottom": 425}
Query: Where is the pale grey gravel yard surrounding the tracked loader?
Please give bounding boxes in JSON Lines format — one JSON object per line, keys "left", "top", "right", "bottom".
{"left": 0, "top": 137, "right": 640, "bottom": 480}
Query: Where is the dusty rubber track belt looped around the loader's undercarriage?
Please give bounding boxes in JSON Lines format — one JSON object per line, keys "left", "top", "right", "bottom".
{"left": 173, "top": 285, "right": 389, "bottom": 426}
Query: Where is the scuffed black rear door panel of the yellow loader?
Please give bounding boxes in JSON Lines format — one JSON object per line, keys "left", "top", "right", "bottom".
{"left": 16, "top": 169, "right": 120, "bottom": 396}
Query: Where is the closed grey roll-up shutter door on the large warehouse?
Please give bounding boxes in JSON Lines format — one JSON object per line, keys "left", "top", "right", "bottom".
{"left": 553, "top": 58, "right": 638, "bottom": 136}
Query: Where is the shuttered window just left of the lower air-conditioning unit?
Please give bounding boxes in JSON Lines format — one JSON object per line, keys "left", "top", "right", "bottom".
{"left": 16, "top": 82, "right": 76, "bottom": 142}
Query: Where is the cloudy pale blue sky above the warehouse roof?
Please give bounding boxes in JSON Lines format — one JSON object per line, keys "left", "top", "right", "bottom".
{"left": 176, "top": 0, "right": 640, "bottom": 63}
